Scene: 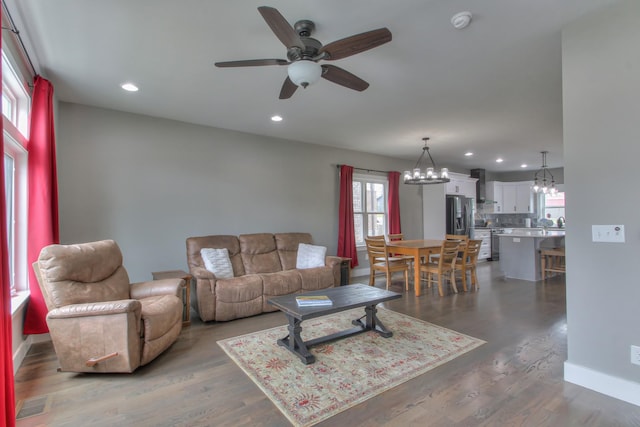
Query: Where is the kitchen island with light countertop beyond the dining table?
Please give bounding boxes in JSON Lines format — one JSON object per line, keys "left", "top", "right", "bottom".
{"left": 498, "top": 229, "right": 565, "bottom": 282}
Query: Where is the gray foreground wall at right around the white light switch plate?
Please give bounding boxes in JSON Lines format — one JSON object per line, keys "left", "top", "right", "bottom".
{"left": 562, "top": 0, "right": 640, "bottom": 405}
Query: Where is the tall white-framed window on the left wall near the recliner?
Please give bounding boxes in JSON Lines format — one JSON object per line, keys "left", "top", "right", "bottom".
{"left": 2, "top": 50, "right": 31, "bottom": 295}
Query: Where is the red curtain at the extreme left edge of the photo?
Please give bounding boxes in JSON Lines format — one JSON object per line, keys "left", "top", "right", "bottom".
{"left": 0, "top": 11, "right": 16, "bottom": 427}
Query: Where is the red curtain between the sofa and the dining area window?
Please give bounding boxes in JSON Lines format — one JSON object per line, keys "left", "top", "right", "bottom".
{"left": 338, "top": 165, "right": 358, "bottom": 268}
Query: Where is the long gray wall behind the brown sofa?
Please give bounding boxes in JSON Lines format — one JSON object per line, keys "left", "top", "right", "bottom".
{"left": 57, "top": 103, "right": 422, "bottom": 281}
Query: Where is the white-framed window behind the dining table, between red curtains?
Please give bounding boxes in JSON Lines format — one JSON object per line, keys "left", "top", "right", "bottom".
{"left": 353, "top": 174, "right": 388, "bottom": 246}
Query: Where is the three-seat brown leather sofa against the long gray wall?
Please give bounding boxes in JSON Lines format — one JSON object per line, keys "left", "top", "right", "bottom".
{"left": 186, "top": 233, "right": 342, "bottom": 321}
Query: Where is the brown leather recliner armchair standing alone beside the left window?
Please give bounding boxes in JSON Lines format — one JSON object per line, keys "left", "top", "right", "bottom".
{"left": 33, "top": 240, "right": 182, "bottom": 372}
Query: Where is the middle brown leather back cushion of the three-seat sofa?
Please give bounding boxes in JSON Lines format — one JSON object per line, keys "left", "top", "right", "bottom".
{"left": 238, "top": 233, "right": 282, "bottom": 274}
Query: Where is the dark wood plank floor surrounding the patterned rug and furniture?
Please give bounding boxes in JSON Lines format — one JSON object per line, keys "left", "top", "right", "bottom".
{"left": 16, "top": 263, "right": 640, "bottom": 427}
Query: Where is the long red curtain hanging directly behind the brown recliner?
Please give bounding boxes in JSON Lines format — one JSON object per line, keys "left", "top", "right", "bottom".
{"left": 24, "top": 76, "right": 60, "bottom": 334}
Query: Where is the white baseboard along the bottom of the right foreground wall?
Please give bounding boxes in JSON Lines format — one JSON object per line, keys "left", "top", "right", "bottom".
{"left": 564, "top": 362, "right": 640, "bottom": 406}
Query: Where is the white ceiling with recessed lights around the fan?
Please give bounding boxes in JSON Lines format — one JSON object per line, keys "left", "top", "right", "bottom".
{"left": 2, "top": 0, "right": 615, "bottom": 172}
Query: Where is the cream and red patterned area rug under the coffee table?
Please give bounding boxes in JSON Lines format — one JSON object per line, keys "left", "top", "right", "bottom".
{"left": 218, "top": 308, "right": 485, "bottom": 427}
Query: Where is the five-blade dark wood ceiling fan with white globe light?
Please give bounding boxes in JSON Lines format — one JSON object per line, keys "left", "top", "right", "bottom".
{"left": 215, "top": 6, "right": 391, "bottom": 99}
